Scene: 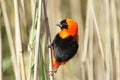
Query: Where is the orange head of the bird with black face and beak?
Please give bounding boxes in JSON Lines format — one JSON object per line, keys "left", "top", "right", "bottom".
{"left": 57, "top": 19, "right": 78, "bottom": 38}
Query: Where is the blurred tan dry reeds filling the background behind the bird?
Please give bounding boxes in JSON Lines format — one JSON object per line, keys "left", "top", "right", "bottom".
{"left": 0, "top": 0, "right": 120, "bottom": 80}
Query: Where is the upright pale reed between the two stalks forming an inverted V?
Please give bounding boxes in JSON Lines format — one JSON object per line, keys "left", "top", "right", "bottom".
{"left": 87, "top": 2, "right": 94, "bottom": 80}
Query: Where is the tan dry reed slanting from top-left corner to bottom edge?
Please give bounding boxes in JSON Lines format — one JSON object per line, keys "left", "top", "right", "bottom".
{"left": 0, "top": 0, "right": 19, "bottom": 80}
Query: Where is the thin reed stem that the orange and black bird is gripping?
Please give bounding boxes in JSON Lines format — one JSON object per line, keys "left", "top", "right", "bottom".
{"left": 42, "top": 0, "right": 54, "bottom": 80}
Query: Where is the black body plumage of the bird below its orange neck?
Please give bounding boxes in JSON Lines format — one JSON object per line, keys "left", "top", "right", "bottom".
{"left": 52, "top": 34, "right": 78, "bottom": 62}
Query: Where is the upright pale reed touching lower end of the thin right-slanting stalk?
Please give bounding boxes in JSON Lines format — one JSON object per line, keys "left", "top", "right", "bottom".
{"left": 105, "top": 0, "right": 112, "bottom": 80}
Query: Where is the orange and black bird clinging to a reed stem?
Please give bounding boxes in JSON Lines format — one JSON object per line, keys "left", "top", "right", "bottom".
{"left": 50, "top": 18, "right": 79, "bottom": 74}
